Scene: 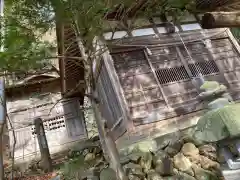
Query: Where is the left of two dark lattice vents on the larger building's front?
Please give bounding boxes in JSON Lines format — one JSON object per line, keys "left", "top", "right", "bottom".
{"left": 156, "top": 66, "right": 190, "bottom": 84}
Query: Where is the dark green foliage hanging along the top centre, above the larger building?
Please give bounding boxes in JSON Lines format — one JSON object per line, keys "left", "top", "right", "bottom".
{"left": 51, "top": 0, "right": 194, "bottom": 48}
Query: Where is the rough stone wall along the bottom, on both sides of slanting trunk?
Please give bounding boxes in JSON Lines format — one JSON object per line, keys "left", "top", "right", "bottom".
{"left": 59, "top": 129, "right": 222, "bottom": 180}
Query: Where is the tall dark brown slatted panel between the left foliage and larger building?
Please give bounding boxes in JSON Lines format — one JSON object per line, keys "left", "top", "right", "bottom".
{"left": 56, "top": 22, "right": 86, "bottom": 101}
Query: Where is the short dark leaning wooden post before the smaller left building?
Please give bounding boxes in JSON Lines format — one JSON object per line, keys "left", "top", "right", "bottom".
{"left": 34, "top": 118, "right": 53, "bottom": 172}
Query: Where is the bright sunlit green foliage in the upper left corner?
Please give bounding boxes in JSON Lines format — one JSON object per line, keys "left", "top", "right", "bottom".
{"left": 0, "top": 0, "right": 54, "bottom": 71}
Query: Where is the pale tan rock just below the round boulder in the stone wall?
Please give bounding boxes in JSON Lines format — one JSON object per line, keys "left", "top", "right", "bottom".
{"left": 173, "top": 153, "right": 194, "bottom": 176}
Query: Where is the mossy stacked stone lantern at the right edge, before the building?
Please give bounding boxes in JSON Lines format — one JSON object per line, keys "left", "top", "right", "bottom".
{"left": 195, "top": 81, "right": 240, "bottom": 179}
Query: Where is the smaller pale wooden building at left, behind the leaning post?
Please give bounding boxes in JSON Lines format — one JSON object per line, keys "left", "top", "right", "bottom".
{"left": 6, "top": 74, "right": 87, "bottom": 162}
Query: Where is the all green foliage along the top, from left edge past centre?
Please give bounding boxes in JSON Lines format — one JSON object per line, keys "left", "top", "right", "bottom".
{"left": 0, "top": 0, "right": 195, "bottom": 71}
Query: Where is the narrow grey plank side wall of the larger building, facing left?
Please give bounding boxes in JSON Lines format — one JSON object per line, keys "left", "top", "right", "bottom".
{"left": 96, "top": 57, "right": 127, "bottom": 140}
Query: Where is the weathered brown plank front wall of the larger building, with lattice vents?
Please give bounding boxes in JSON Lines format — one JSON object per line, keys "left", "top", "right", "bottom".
{"left": 109, "top": 29, "right": 240, "bottom": 125}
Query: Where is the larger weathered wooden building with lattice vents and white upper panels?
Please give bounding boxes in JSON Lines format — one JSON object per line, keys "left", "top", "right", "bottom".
{"left": 93, "top": 14, "right": 240, "bottom": 149}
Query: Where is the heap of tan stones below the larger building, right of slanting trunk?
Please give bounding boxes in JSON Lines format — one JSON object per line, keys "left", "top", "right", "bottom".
{"left": 116, "top": 136, "right": 221, "bottom": 180}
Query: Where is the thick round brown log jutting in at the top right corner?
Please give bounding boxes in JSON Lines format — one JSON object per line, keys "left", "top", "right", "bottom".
{"left": 201, "top": 11, "right": 240, "bottom": 29}
